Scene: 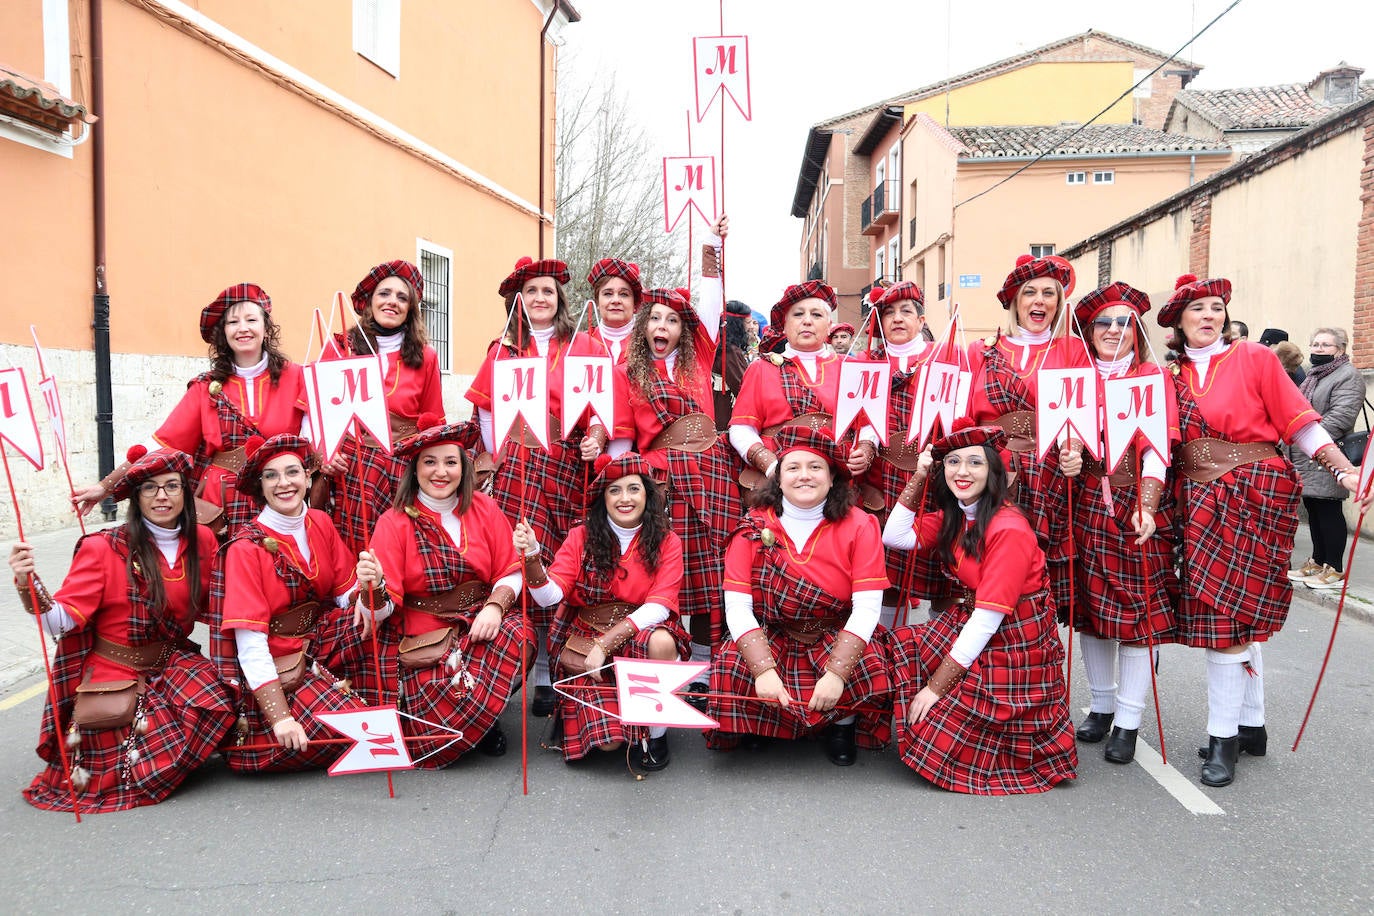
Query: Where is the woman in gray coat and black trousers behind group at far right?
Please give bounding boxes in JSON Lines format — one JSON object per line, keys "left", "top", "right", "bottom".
{"left": 1289, "top": 328, "right": 1364, "bottom": 589}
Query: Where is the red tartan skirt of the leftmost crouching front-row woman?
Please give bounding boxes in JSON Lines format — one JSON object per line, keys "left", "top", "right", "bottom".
{"left": 23, "top": 650, "right": 234, "bottom": 814}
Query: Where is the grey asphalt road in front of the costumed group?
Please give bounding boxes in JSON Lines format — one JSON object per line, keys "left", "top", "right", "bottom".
{"left": 0, "top": 600, "right": 1374, "bottom": 913}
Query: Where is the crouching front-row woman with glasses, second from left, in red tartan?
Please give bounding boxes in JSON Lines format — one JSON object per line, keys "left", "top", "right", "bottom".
{"left": 210, "top": 434, "right": 367, "bottom": 772}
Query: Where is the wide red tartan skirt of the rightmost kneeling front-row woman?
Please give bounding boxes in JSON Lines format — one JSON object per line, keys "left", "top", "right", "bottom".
{"left": 889, "top": 604, "right": 1079, "bottom": 795}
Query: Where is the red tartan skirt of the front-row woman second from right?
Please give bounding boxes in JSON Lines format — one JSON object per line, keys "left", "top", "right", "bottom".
{"left": 706, "top": 625, "right": 892, "bottom": 750}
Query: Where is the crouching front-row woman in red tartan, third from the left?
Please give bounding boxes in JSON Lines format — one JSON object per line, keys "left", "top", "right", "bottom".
{"left": 357, "top": 417, "right": 533, "bottom": 768}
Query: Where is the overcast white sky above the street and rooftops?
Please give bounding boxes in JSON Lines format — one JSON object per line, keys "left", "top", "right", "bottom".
{"left": 563, "top": 0, "right": 1374, "bottom": 313}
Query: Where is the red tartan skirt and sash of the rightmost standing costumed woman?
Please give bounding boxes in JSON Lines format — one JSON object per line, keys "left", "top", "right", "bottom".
{"left": 1175, "top": 379, "right": 1303, "bottom": 648}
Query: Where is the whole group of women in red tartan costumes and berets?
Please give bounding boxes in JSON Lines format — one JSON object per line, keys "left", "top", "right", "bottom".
{"left": 10, "top": 230, "right": 1358, "bottom": 810}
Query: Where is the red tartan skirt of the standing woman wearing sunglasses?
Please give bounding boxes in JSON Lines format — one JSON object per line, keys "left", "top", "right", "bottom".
{"left": 1062, "top": 469, "right": 1179, "bottom": 644}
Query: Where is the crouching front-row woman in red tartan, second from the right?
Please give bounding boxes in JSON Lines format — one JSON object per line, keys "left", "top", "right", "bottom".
{"left": 706, "top": 427, "right": 890, "bottom": 766}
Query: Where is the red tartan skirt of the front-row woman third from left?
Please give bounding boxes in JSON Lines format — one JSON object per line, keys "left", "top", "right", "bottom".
{"left": 396, "top": 615, "right": 529, "bottom": 769}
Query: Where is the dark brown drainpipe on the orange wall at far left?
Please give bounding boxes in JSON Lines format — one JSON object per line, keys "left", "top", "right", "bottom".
{"left": 91, "top": 0, "right": 115, "bottom": 522}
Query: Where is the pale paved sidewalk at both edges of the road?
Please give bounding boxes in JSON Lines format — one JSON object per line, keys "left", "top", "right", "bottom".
{"left": 0, "top": 512, "right": 1374, "bottom": 691}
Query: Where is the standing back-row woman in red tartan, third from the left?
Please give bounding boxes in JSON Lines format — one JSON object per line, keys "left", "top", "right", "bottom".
{"left": 467, "top": 258, "right": 609, "bottom": 715}
